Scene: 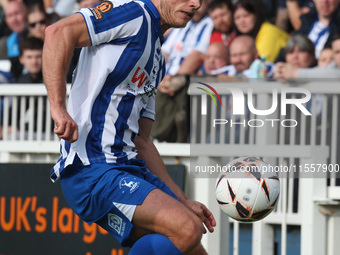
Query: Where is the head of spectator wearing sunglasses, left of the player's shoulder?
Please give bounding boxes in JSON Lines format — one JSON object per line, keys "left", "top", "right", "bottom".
{"left": 27, "top": 4, "right": 50, "bottom": 40}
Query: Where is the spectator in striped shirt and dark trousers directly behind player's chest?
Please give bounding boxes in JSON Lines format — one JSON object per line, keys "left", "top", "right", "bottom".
{"left": 151, "top": 0, "right": 214, "bottom": 142}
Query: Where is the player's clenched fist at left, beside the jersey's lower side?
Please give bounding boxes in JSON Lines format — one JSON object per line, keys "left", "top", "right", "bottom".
{"left": 51, "top": 104, "right": 78, "bottom": 143}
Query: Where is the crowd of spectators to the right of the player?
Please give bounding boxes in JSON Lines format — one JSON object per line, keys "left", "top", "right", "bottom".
{"left": 151, "top": 0, "right": 340, "bottom": 142}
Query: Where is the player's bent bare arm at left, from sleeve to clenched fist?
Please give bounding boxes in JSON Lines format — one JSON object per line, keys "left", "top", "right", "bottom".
{"left": 43, "top": 13, "right": 91, "bottom": 142}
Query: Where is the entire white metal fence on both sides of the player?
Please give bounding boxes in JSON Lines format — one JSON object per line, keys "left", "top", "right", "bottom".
{"left": 0, "top": 81, "right": 340, "bottom": 255}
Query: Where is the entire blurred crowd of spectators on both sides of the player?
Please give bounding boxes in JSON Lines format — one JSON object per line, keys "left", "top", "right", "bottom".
{"left": 0, "top": 0, "right": 340, "bottom": 142}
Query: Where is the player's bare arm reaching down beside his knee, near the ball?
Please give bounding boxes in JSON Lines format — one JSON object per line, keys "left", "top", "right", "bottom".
{"left": 135, "top": 118, "right": 216, "bottom": 232}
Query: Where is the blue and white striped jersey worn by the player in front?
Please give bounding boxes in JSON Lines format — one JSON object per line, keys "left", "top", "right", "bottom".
{"left": 51, "top": 0, "right": 165, "bottom": 181}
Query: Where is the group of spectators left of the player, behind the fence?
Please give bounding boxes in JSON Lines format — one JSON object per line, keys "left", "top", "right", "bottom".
{"left": 0, "top": 0, "right": 101, "bottom": 139}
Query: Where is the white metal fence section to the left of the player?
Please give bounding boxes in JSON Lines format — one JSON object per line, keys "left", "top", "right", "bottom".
{"left": 0, "top": 84, "right": 70, "bottom": 163}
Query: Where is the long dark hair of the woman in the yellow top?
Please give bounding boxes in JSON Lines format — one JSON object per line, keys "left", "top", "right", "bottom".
{"left": 233, "top": 0, "right": 265, "bottom": 38}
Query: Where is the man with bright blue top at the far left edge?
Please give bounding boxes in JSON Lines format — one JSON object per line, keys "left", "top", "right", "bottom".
{"left": 0, "top": 0, "right": 27, "bottom": 77}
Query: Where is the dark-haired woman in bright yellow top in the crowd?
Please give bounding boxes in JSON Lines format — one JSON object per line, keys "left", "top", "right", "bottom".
{"left": 234, "top": 0, "right": 289, "bottom": 62}
